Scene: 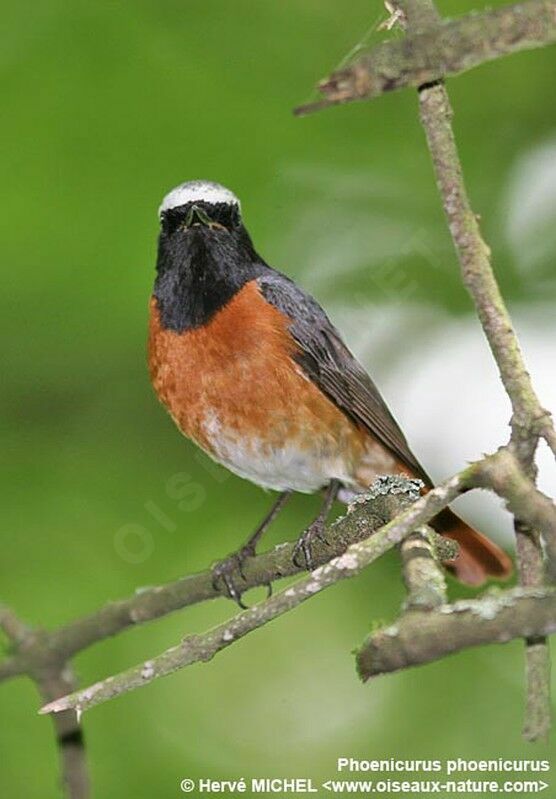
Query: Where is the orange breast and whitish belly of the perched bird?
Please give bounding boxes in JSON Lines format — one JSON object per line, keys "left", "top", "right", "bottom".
{"left": 149, "top": 281, "right": 402, "bottom": 491}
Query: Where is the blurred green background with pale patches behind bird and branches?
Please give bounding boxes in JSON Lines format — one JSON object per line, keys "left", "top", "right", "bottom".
{"left": 0, "top": 0, "right": 556, "bottom": 799}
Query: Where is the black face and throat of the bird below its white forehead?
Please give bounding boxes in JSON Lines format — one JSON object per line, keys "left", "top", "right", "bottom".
{"left": 154, "top": 208, "right": 268, "bottom": 333}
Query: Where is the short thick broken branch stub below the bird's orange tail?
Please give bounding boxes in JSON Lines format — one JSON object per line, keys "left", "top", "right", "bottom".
{"left": 356, "top": 587, "right": 556, "bottom": 680}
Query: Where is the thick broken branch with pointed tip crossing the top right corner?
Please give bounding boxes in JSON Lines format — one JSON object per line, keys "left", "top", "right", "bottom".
{"left": 295, "top": 0, "right": 556, "bottom": 115}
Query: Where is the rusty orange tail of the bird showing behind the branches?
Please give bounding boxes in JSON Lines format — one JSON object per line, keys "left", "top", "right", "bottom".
{"left": 432, "top": 508, "right": 513, "bottom": 585}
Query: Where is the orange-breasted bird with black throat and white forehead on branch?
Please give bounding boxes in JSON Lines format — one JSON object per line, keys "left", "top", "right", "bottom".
{"left": 148, "top": 180, "right": 512, "bottom": 607}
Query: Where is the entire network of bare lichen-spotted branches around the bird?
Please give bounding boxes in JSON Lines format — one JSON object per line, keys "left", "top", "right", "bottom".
{"left": 4, "top": 0, "right": 556, "bottom": 764}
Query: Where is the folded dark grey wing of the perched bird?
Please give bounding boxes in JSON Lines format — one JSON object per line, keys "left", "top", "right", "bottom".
{"left": 257, "top": 270, "right": 431, "bottom": 484}
